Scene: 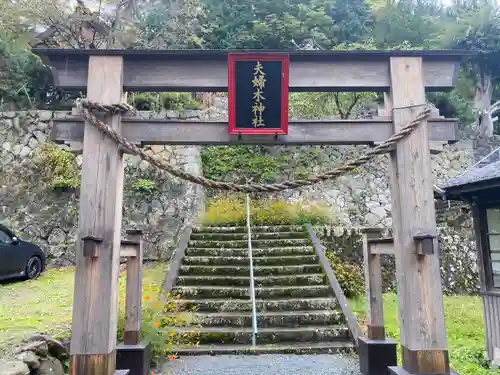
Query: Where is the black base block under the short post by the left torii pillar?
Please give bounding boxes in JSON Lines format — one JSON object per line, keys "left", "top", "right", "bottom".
{"left": 116, "top": 342, "right": 151, "bottom": 375}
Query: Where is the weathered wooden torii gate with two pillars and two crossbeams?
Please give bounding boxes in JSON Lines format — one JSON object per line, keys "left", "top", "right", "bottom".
{"left": 33, "top": 49, "right": 464, "bottom": 375}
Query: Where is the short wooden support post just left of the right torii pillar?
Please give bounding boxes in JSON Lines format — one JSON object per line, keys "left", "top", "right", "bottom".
{"left": 363, "top": 228, "right": 385, "bottom": 340}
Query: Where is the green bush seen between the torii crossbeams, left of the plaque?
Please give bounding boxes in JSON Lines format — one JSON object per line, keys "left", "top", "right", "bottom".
{"left": 131, "top": 92, "right": 201, "bottom": 112}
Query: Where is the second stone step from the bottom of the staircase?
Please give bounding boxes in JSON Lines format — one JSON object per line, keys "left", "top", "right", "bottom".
{"left": 171, "top": 325, "right": 349, "bottom": 345}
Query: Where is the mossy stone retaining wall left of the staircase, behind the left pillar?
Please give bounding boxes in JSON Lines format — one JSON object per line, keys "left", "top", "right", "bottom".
{"left": 0, "top": 111, "right": 204, "bottom": 263}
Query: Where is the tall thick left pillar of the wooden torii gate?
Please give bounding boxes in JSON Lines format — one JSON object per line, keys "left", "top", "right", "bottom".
{"left": 70, "top": 56, "right": 124, "bottom": 375}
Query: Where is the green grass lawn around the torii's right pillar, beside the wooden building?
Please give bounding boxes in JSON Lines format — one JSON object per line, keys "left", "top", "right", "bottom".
{"left": 351, "top": 294, "right": 500, "bottom": 375}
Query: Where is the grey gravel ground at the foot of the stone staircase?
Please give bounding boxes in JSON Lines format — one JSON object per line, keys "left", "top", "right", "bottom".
{"left": 155, "top": 354, "right": 361, "bottom": 375}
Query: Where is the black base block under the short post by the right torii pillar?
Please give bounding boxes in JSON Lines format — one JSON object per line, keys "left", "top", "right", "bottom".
{"left": 358, "top": 337, "right": 398, "bottom": 375}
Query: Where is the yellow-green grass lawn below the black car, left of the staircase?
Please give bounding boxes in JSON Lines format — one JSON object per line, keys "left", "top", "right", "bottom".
{"left": 0, "top": 263, "right": 166, "bottom": 353}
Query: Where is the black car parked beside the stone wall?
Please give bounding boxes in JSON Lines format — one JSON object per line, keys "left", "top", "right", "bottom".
{"left": 0, "top": 224, "right": 45, "bottom": 280}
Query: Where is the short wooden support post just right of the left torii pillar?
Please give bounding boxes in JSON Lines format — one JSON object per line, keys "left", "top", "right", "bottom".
{"left": 122, "top": 230, "right": 143, "bottom": 345}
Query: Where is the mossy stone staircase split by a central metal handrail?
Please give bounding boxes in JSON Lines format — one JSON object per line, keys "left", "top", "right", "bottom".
{"left": 174, "top": 226, "right": 354, "bottom": 355}
